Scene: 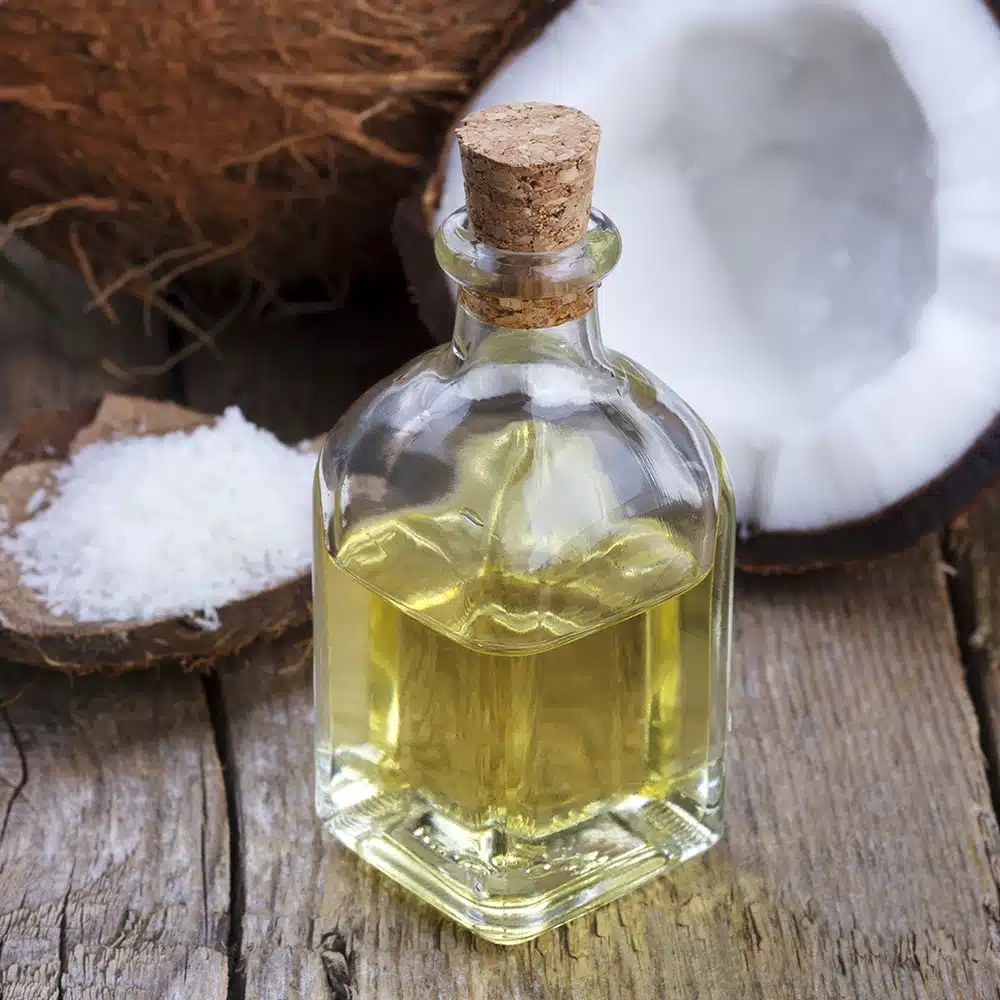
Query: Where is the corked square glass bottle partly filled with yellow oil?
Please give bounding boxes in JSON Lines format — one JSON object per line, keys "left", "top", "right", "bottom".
{"left": 313, "top": 104, "right": 734, "bottom": 944}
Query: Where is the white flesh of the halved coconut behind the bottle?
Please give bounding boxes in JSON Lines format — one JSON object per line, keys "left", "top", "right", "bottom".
{"left": 439, "top": 0, "right": 1000, "bottom": 531}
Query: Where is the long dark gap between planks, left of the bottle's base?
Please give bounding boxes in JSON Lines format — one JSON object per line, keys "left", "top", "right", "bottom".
{"left": 202, "top": 670, "right": 246, "bottom": 1000}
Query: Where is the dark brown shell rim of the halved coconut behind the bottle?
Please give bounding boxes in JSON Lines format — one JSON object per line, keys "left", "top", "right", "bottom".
{"left": 393, "top": 137, "right": 1000, "bottom": 574}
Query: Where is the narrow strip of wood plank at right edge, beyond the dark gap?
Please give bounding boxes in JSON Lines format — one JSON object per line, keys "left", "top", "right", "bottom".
{"left": 951, "top": 487, "right": 1000, "bottom": 794}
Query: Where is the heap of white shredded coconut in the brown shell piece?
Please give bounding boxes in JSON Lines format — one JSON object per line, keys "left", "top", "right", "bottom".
{"left": 0, "top": 407, "right": 316, "bottom": 628}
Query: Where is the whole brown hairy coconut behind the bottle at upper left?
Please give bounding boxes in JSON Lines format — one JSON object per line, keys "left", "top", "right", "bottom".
{"left": 0, "top": 0, "right": 566, "bottom": 312}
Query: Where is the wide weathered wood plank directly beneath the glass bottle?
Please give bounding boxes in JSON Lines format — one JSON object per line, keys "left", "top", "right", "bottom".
{"left": 215, "top": 545, "right": 1000, "bottom": 1000}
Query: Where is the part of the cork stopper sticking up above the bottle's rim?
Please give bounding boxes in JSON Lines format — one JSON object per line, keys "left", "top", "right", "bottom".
{"left": 456, "top": 102, "right": 601, "bottom": 252}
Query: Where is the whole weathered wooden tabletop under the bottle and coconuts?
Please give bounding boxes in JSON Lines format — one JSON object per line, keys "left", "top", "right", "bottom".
{"left": 0, "top": 262, "right": 1000, "bottom": 1000}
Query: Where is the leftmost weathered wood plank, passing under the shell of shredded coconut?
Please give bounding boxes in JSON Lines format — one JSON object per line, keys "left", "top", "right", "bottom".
{"left": 0, "top": 248, "right": 229, "bottom": 1000}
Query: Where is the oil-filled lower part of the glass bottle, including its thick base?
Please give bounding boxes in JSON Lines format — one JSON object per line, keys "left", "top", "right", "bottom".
{"left": 314, "top": 496, "right": 731, "bottom": 943}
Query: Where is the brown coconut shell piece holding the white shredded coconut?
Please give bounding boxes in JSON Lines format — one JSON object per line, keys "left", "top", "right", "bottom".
{"left": 0, "top": 395, "right": 320, "bottom": 674}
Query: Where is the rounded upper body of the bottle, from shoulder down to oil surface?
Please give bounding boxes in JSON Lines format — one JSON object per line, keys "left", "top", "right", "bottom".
{"left": 318, "top": 347, "right": 731, "bottom": 644}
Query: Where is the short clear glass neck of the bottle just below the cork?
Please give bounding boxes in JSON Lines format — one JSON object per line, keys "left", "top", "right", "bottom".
{"left": 451, "top": 294, "right": 608, "bottom": 365}
